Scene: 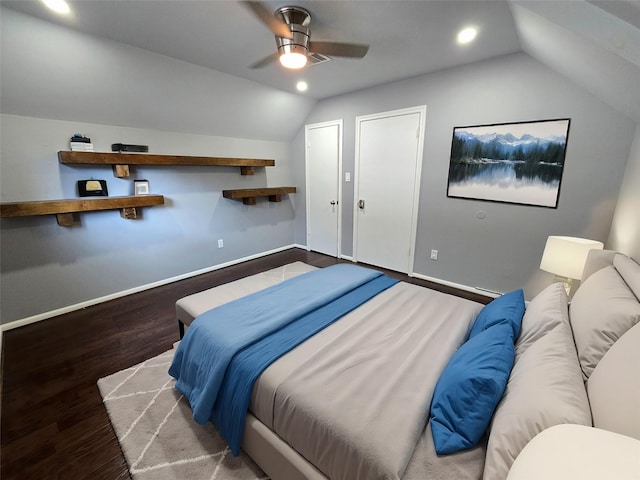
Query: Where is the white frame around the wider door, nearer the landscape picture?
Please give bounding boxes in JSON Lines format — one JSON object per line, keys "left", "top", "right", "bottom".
{"left": 353, "top": 105, "right": 427, "bottom": 277}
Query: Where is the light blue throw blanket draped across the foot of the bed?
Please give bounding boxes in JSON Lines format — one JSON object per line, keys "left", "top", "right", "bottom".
{"left": 169, "top": 264, "right": 395, "bottom": 454}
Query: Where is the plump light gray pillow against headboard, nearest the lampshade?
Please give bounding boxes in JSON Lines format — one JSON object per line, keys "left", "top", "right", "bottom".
{"left": 569, "top": 265, "right": 640, "bottom": 380}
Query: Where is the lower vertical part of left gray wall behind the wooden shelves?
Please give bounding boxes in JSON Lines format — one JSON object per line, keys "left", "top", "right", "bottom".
{"left": 0, "top": 115, "right": 295, "bottom": 323}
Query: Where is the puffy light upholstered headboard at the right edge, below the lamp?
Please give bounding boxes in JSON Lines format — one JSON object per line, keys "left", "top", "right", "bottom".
{"left": 571, "top": 250, "right": 640, "bottom": 439}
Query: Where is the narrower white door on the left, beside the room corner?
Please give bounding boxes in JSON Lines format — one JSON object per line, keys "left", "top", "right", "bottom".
{"left": 305, "top": 120, "right": 342, "bottom": 257}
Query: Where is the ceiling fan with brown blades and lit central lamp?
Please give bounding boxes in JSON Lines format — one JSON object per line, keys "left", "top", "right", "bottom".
{"left": 243, "top": 1, "right": 369, "bottom": 69}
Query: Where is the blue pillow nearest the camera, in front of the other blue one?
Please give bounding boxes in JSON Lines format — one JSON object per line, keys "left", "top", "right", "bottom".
{"left": 431, "top": 324, "right": 515, "bottom": 455}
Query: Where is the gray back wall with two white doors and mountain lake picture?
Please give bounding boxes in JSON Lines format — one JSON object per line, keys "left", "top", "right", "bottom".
{"left": 294, "top": 54, "right": 636, "bottom": 297}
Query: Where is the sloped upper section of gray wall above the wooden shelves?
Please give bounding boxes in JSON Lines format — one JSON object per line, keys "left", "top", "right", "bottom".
{"left": 0, "top": 7, "right": 315, "bottom": 142}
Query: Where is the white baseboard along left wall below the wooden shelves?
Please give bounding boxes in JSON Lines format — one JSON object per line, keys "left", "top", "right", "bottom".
{"left": 0, "top": 244, "right": 298, "bottom": 330}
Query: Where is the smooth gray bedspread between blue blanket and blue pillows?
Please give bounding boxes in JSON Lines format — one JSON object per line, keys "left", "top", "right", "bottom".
{"left": 250, "top": 283, "right": 484, "bottom": 480}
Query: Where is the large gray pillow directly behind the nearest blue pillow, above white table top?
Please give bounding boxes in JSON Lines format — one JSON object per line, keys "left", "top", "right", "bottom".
{"left": 483, "top": 314, "right": 591, "bottom": 480}
